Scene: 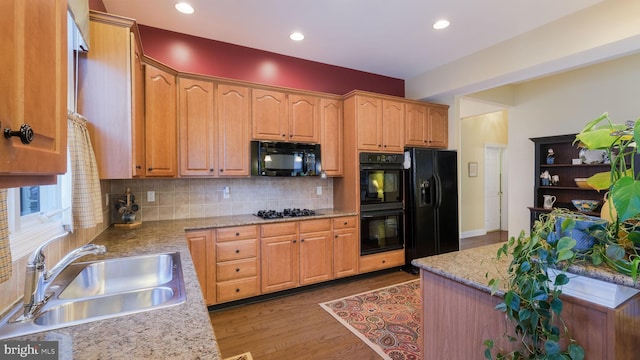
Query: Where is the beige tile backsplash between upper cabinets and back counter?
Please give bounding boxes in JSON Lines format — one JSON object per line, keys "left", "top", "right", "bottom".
{"left": 110, "top": 177, "right": 333, "bottom": 221}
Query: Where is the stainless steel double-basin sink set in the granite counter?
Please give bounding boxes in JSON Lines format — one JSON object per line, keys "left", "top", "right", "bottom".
{"left": 0, "top": 253, "right": 186, "bottom": 339}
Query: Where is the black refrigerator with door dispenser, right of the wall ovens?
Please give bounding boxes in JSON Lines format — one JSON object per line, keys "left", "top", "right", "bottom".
{"left": 404, "top": 148, "right": 460, "bottom": 273}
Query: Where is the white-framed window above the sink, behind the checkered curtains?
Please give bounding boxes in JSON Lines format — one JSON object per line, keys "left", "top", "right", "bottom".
{"left": 7, "top": 11, "right": 77, "bottom": 260}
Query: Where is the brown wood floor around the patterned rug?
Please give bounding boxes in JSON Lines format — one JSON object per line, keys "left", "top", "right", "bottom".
{"left": 210, "top": 233, "right": 506, "bottom": 360}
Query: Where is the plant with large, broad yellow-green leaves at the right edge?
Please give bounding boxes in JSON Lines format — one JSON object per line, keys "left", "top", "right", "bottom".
{"left": 576, "top": 113, "right": 640, "bottom": 281}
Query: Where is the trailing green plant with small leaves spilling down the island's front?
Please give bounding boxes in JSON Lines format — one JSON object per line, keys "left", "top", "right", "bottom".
{"left": 484, "top": 219, "right": 584, "bottom": 360}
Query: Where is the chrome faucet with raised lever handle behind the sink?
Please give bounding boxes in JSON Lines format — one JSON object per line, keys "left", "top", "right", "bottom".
{"left": 22, "top": 232, "right": 107, "bottom": 320}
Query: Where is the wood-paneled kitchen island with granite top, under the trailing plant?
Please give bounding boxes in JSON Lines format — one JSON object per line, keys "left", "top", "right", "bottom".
{"left": 412, "top": 243, "right": 640, "bottom": 360}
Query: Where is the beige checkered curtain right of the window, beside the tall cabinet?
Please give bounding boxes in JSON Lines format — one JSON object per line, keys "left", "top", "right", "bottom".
{"left": 67, "top": 111, "right": 102, "bottom": 231}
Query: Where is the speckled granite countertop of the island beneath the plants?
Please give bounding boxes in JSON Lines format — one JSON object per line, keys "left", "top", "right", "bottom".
{"left": 411, "top": 239, "right": 640, "bottom": 292}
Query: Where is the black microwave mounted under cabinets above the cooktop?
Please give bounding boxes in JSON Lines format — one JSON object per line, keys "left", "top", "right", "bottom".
{"left": 251, "top": 141, "right": 321, "bottom": 176}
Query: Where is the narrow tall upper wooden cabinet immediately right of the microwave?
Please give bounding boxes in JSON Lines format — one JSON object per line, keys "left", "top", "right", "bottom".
{"left": 320, "top": 98, "right": 344, "bottom": 176}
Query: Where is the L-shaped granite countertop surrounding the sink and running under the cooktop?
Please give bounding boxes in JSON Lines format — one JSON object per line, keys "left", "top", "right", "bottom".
{"left": 7, "top": 210, "right": 356, "bottom": 360}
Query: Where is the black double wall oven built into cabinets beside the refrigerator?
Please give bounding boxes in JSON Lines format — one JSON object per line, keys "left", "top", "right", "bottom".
{"left": 360, "top": 153, "right": 404, "bottom": 255}
